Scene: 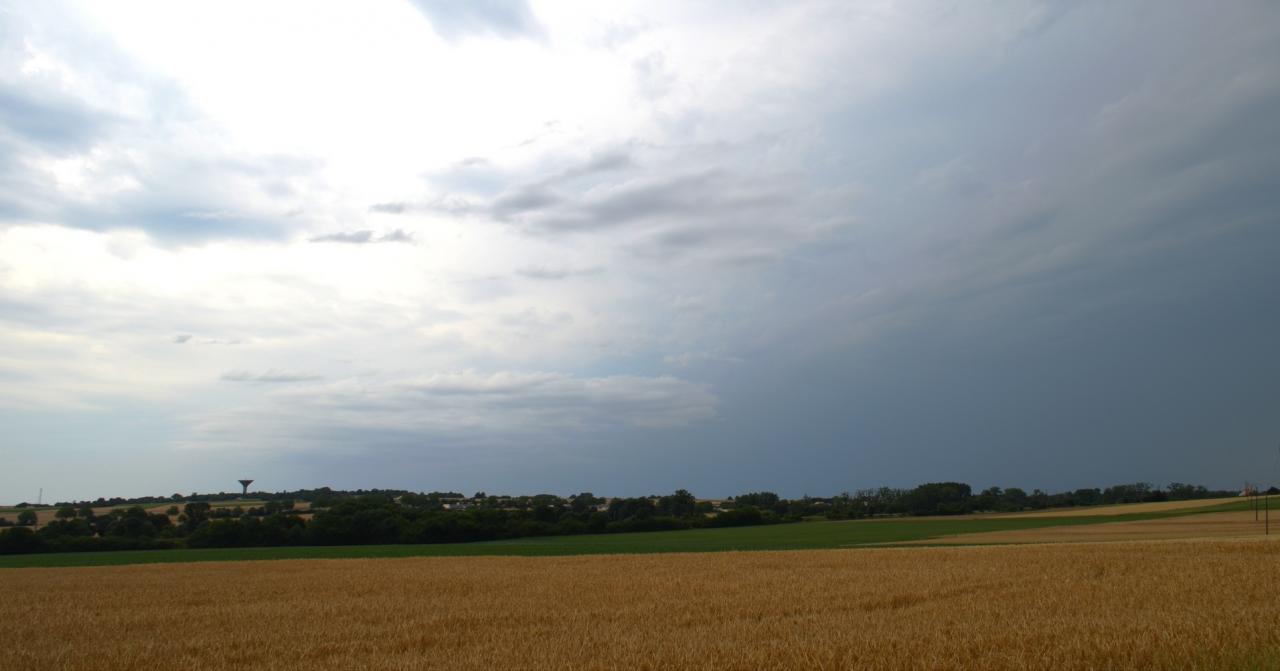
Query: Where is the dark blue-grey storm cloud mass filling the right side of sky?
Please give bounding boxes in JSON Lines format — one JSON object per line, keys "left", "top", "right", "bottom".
{"left": 680, "top": 4, "right": 1280, "bottom": 489}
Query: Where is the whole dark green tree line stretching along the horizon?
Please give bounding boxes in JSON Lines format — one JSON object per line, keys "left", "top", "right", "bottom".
{"left": 0, "top": 483, "right": 1235, "bottom": 554}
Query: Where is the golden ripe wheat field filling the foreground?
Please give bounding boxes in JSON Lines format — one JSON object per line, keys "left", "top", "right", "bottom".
{"left": 0, "top": 539, "right": 1280, "bottom": 670}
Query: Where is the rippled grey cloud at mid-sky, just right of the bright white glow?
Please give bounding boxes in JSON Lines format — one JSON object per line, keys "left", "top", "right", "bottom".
{"left": 419, "top": 142, "right": 855, "bottom": 263}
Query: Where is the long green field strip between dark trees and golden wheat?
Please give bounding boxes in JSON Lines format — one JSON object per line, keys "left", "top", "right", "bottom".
{"left": 0, "top": 501, "right": 1248, "bottom": 569}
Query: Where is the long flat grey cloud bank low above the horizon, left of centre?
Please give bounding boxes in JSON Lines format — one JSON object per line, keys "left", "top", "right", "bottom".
{"left": 188, "top": 371, "right": 717, "bottom": 449}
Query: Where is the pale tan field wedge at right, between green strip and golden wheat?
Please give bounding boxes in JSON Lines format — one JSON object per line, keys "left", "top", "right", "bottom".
{"left": 899, "top": 511, "right": 1280, "bottom": 546}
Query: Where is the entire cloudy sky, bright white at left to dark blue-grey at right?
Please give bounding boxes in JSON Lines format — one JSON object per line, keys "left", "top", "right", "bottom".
{"left": 0, "top": 0, "right": 1280, "bottom": 502}
